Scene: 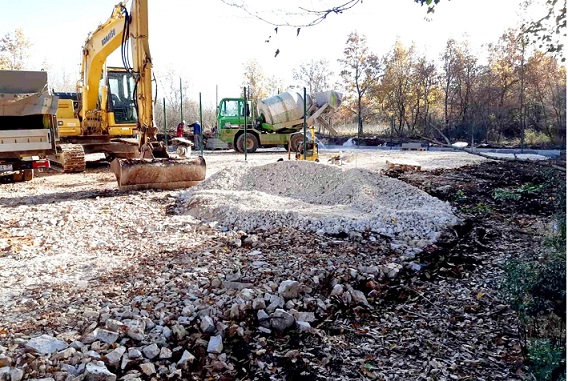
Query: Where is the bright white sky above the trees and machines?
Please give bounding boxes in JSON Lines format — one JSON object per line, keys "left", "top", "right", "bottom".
{"left": 0, "top": 0, "right": 531, "bottom": 107}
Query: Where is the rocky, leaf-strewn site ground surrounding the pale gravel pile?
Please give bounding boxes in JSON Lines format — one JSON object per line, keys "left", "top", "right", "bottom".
{"left": 0, "top": 150, "right": 565, "bottom": 381}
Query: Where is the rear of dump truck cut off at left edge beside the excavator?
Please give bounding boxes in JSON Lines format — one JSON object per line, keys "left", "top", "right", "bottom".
{"left": 0, "top": 70, "right": 57, "bottom": 181}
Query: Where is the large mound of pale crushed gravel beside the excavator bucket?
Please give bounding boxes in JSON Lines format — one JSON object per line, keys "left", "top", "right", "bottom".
{"left": 180, "top": 161, "right": 458, "bottom": 247}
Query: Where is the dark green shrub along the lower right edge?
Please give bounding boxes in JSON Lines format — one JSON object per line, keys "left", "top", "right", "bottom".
{"left": 500, "top": 172, "right": 566, "bottom": 381}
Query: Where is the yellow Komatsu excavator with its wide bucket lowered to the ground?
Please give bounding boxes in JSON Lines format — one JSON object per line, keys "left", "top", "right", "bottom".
{"left": 52, "top": 0, "right": 206, "bottom": 189}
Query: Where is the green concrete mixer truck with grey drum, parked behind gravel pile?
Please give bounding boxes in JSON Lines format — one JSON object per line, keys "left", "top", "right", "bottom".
{"left": 217, "top": 90, "right": 342, "bottom": 153}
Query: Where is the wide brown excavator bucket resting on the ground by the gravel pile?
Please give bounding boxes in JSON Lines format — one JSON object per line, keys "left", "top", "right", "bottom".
{"left": 110, "top": 156, "right": 206, "bottom": 190}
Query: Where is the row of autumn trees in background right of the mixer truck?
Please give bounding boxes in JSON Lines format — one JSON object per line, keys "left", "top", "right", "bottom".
{"left": 338, "top": 30, "right": 566, "bottom": 144}
